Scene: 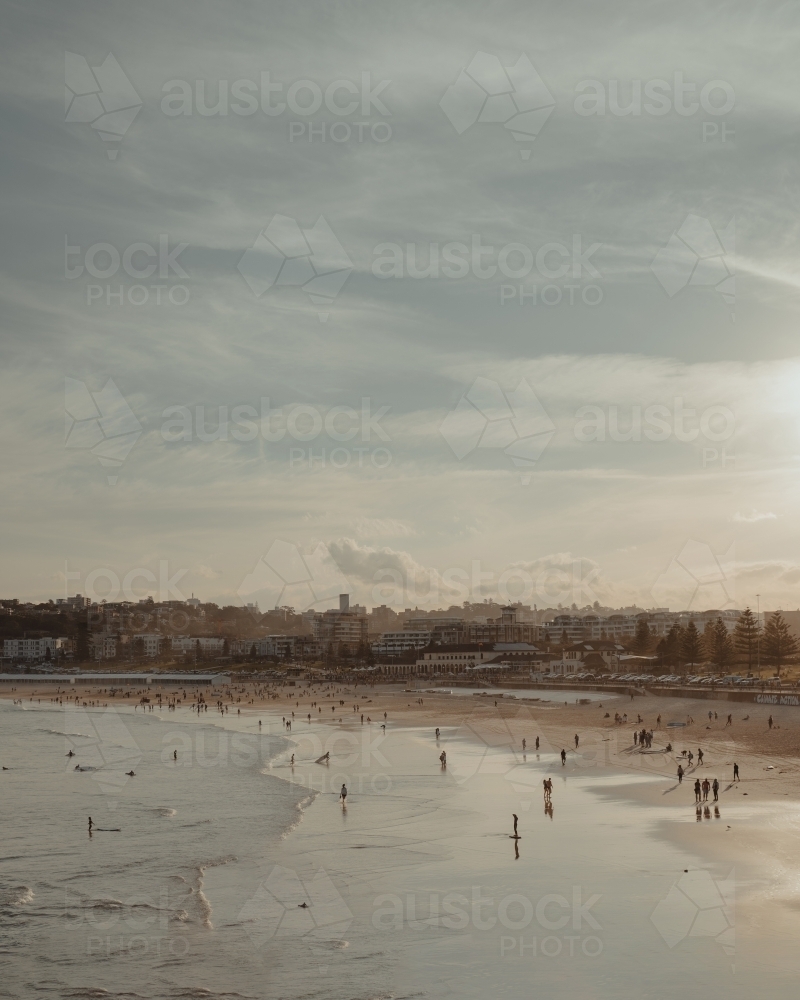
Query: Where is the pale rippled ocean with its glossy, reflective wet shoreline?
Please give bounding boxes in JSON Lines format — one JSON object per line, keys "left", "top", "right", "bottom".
{"left": 0, "top": 699, "right": 800, "bottom": 1000}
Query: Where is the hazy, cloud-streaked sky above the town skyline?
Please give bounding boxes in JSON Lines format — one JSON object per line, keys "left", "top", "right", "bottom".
{"left": 0, "top": 0, "right": 800, "bottom": 611}
